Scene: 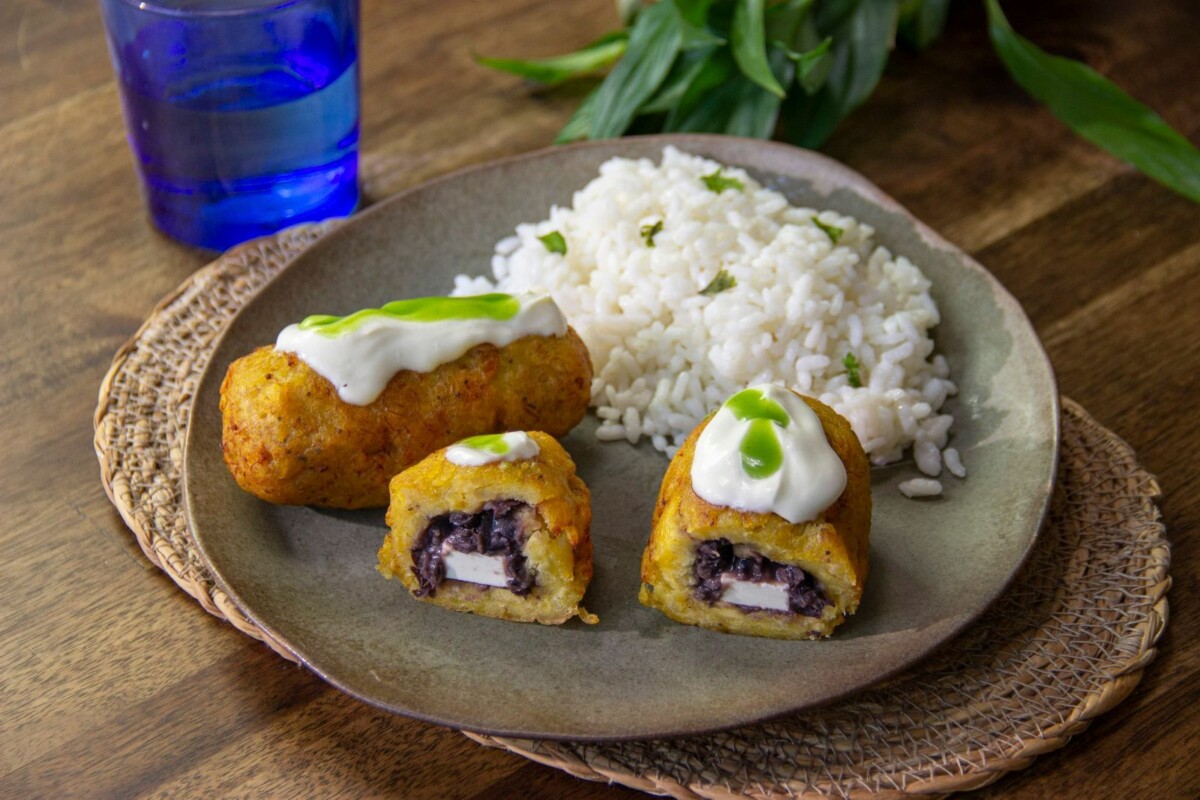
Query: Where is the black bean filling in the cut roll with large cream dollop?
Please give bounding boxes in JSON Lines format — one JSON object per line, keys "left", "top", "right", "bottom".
{"left": 694, "top": 539, "right": 830, "bottom": 616}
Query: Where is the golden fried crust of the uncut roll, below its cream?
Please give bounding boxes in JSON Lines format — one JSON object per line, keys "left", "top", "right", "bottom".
{"left": 221, "top": 329, "right": 592, "bottom": 509}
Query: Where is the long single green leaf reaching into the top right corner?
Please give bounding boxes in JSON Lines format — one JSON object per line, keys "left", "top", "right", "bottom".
{"left": 988, "top": 0, "right": 1200, "bottom": 203}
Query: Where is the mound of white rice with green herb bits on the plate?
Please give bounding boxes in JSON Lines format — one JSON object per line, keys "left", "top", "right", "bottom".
{"left": 454, "top": 148, "right": 956, "bottom": 489}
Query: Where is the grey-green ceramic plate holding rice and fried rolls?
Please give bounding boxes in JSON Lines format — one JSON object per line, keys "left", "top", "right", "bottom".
{"left": 185, "top": 136, "right": 1058, "bottom": 739}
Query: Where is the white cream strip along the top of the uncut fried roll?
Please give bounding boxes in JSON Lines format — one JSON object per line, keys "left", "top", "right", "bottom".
{"left": 275, "top": 295, "right": 566, "bottom": 405}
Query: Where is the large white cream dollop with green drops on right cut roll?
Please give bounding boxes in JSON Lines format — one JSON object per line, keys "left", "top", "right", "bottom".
{"left": 691, "top": 384, "right": 846, "bottom": 523}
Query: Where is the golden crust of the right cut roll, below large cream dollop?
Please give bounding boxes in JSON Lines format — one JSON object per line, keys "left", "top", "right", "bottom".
{"left": 638, "top": 395, "right": 871, "bottom": 639}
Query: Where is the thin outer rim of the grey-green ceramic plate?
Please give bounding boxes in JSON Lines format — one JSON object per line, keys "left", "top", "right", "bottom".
{"left": 180, "top": 133, "right": 1062, "bottom": 742}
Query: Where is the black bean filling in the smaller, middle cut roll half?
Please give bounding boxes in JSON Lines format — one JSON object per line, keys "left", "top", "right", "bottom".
{"left": 413, "top": 500, "right": 533, "bottom": 597}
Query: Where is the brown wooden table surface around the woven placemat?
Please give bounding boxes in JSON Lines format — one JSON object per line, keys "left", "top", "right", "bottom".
{"left": 0, "top": 0, "right": 1200, "bottom": 799}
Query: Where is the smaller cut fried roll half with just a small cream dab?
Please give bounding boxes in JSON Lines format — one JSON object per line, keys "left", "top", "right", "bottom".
{"left": 379, "top": 431, "right": 596, "bottom": 625}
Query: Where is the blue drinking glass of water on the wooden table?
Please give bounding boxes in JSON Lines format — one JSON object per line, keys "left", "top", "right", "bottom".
{"left": 100, "top": 0, "right": 359, "bottom": 249}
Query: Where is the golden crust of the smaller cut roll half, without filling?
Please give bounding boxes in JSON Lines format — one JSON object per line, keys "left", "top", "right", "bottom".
{"left": 379, "top": 431, "right": 595, "bottom": 625}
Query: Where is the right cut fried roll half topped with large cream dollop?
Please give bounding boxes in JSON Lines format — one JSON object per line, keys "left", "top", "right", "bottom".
{"left": 638, "top": 385, "right": 871, "bottom": 639}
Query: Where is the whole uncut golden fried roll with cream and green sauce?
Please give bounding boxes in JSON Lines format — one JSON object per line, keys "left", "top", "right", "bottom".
{"left": 221, "top": 294, "right": 592, "bottom": 509}
